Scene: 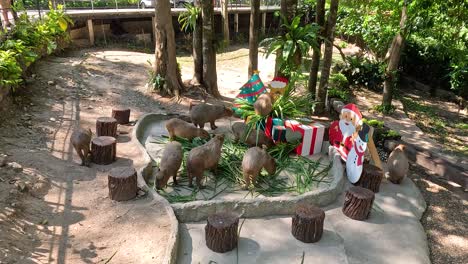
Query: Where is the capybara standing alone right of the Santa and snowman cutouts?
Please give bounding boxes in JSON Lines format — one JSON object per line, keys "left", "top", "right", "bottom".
{"left": 387, "top": 144, "right": 409, "bottom": 184}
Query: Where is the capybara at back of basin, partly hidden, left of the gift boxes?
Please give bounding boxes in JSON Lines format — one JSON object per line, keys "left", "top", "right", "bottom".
{"left": 231, "top": 122, "right": 274, "bottom": 147}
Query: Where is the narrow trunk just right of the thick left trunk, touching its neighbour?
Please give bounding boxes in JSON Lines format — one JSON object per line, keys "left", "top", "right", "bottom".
{"left": 191, "top": 0, "right": 203, "bottom": 85}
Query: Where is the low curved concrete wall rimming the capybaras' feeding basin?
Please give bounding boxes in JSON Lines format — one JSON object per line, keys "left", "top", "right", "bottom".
{"left": 134, "top": 114, "right": 345, "bottom": 222}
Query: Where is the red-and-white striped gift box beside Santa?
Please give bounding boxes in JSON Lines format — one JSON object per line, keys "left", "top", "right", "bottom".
{"left": 284, "top": 120, "right": 325, "bottom": 156}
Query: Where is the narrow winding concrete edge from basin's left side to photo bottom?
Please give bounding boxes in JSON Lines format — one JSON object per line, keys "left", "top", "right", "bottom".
{"left": 132, "top": 114, "right": 179, "bottom": 264}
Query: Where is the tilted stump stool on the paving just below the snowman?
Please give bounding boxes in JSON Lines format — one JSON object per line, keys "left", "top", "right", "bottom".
{"left": 343, "top": 186, "right": 375, "bottom": 220}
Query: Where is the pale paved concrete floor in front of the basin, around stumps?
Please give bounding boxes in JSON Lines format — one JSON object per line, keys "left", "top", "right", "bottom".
{"left": 177, "top": 178, "right": 430, "bottom": 264}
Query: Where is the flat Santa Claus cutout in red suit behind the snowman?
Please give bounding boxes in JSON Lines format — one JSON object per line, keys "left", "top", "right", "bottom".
{"left": 329, "top": 104, "right": 362, "bottom": 161}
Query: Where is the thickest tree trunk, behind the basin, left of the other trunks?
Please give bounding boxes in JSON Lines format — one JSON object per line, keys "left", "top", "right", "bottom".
{"left": 154, "top": 0, "right": 183, "bottom": 97}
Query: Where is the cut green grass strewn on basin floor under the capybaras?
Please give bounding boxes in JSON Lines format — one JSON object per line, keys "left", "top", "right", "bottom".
{"left": 150, "top": 134, "right": 331, "bottom": 203}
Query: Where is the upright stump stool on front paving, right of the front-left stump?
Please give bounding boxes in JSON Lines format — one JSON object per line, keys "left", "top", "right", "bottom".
{"left": 291, "top": 204, "right": 325, "bottom": 243}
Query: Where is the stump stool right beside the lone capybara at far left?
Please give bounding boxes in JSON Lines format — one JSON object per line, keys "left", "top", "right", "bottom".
{"left": 91, "top": 136, "right": 117, "bottom": 165}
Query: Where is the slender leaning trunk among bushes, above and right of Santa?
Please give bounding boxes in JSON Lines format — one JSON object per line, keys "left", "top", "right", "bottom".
{"left": 382, "top": 5, "right": 408, "bottom": 107}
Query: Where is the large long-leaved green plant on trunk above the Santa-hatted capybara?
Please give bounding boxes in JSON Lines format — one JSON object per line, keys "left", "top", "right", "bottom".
{"left": 260, "top": 13, "right": 319, "bottom": 76}
